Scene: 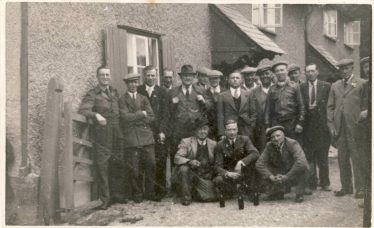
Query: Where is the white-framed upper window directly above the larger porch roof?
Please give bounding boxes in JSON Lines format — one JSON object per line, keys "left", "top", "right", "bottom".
{"left": 252, "top": 4, "right": 283, "bottom": 32}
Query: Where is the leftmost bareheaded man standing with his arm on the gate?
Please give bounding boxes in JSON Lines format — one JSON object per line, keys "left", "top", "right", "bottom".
{"left": 79, "top": 66, "right": 126, "bottom": 210}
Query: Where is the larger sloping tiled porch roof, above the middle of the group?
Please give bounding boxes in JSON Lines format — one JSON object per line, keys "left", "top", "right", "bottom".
{"left": 215, "top": 5, "right": 286, "bottom": 54}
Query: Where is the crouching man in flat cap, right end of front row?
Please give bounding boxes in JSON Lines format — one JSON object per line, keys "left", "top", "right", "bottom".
{"left": 256, "top": 126, "right": 308, "bottom": 203}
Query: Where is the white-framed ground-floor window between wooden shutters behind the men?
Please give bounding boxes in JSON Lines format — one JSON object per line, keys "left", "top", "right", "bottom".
{"left": 127, "top": 33, "right": 160, "bottom": 84}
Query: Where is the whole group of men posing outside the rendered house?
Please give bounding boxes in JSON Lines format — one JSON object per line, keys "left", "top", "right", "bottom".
{"left": 80, "top": 55, "right": 369, "bottom": 209}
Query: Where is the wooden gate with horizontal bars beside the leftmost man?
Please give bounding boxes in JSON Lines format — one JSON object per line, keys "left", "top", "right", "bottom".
{"left": 61, "top": 102, "right": 101, "bottom": 218}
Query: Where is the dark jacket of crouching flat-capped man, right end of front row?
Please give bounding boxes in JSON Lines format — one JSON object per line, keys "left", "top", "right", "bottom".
{"left": 256, "top": 137, "right": 308, "bottom": 180}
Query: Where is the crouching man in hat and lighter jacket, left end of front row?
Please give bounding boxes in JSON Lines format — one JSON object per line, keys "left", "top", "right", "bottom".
{"left": 172, "top": 117, "right": 216, "bottom": 206}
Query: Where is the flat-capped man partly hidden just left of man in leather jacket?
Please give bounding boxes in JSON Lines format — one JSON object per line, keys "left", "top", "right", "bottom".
{"left": 252, "top": 65, "right": 272, "bottom": 153}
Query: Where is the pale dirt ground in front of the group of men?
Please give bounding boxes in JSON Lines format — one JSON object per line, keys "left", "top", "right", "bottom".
{"left": 66, "top": 158, "right": 363, "bottom": 227}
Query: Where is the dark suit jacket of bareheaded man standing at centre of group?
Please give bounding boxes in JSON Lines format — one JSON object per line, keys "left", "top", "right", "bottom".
{"left": 217, "top": 89, "right": 256, "bottom": 135}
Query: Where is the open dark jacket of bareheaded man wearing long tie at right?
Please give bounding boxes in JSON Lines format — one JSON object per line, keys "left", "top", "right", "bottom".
{"left": 300, "top": 80, "right": 331, "bottom": 140}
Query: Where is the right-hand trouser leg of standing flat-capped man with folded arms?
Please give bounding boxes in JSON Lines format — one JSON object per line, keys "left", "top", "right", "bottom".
{"left": 141, "top": 145, "right": 156, "bottom": 198}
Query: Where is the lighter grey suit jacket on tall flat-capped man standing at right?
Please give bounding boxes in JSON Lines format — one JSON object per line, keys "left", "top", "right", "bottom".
{"left": 327, "top": 76, "right": 367, "bottom": 135}
